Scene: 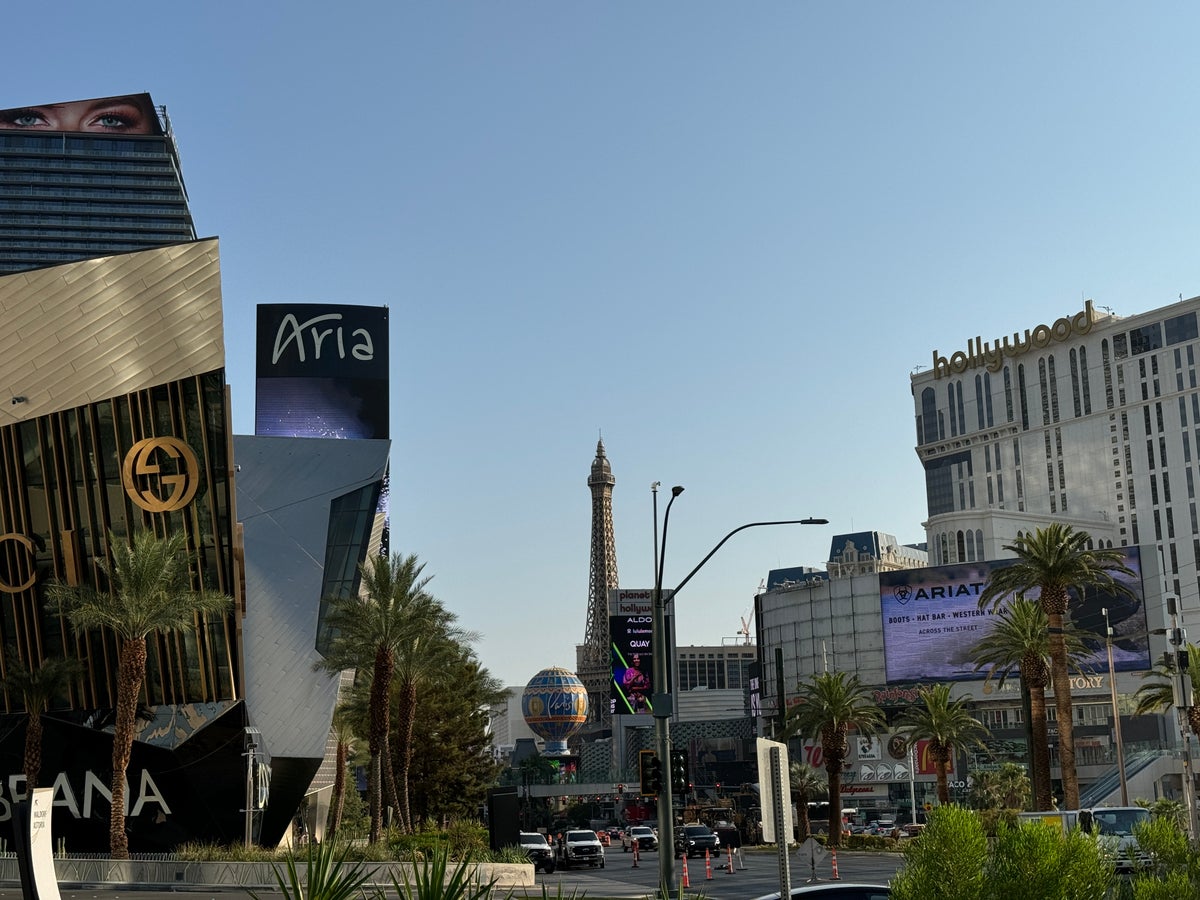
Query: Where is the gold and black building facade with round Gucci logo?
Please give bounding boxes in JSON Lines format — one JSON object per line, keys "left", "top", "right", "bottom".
{"left": 0, "top": 239, "right": 247, "bottom": 850}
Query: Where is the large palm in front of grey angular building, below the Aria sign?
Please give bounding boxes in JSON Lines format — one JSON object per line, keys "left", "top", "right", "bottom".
{"left": 318, "top": 553, "right": 450, "bottom": 844}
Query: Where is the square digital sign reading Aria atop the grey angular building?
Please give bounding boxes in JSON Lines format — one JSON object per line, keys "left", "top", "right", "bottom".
{"left": 254, "top": 304, "right": 390, "bottom": 439}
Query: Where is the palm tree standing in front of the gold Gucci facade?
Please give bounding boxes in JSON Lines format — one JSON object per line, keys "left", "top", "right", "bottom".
{"left": 47, "top": 529, "right": 233, "bottom": 859}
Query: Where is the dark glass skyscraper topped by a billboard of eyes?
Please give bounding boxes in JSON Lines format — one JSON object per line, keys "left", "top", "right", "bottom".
{"left": 0, "top": 94, "right": 196, "bottom": 274}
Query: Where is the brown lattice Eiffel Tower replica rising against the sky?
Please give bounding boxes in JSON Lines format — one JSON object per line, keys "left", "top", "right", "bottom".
{"left": 576, "top": 439, "right": 618, "bottom": 725}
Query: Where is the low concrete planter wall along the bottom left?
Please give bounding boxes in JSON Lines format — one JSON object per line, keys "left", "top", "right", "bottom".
{"left": 0, "top": 856, "right": 534, "bottom": 890}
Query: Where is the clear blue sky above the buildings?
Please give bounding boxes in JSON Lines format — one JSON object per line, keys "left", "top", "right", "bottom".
{"left": 14, "top": 0, "right": 1200, "bottom": 684}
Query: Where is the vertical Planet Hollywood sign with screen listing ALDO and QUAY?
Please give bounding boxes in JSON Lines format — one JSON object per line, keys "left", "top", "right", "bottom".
{"left": 608, "top": 589, "right": 671, "bottom": 715}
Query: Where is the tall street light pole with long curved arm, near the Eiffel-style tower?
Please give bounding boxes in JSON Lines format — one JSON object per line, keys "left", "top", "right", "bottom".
{"left": 650, "top": 511, "right": 829, "bottom": 896}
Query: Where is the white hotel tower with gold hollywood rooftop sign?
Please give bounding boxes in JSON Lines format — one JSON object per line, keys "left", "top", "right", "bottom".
{"left": 912, "top": 298, "right": 1200, "bottom": 625}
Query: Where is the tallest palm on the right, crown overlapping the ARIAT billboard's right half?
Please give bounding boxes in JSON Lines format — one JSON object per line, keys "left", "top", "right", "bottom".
{"left": 979, "top": 522, "right": 1135, "bottom": 809}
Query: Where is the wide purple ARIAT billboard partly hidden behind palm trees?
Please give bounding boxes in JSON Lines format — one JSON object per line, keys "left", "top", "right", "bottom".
{"left": 880, "top": 547, "right": 1150, "bottom": 683}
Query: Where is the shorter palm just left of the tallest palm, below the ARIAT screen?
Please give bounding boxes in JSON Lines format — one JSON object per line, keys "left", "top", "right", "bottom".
{"left": 971, "top": 596, "right": 1090, "bottom": 810}
